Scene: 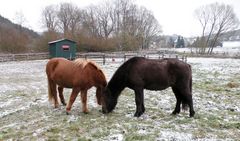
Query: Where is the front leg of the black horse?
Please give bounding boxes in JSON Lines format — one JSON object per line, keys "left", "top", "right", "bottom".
{"left": 134, "top": 89, "right": 145, "bottom": 117}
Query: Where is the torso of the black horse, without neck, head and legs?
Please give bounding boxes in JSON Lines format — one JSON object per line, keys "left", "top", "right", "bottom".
{"left": 127, "top": 57, "right": 191, "bottom": 90}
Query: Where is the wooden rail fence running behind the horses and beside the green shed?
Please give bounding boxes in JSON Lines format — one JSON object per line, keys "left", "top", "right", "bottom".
{"left": 0, "top": 52, "right": 187, "bottom": 64}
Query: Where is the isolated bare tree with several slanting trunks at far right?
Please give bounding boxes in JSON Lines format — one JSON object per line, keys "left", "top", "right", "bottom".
{"left": 195, "top": 3, "right": 239, "bottom": 54}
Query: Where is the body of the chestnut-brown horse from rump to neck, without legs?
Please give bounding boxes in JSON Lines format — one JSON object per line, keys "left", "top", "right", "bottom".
{"left": 46, "top": 58, "right": 107, "bottom": 88}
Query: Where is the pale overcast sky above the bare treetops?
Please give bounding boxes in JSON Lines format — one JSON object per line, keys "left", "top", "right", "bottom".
{"left": 0, "top": 0, "right": 240, "bottom": 37}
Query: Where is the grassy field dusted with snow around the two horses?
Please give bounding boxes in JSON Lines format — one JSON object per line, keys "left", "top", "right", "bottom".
{"left": 0, "top": 58, "right": 240, "bottom": 141}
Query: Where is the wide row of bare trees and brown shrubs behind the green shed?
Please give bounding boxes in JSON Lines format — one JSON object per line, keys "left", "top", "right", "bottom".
{"left": 37, "top": 0, "right": 161, "bottom": 51}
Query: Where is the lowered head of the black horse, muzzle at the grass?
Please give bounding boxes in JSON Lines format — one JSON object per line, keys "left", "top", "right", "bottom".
{"left": 102, "top": 87, "right": 117, "bottom": 114}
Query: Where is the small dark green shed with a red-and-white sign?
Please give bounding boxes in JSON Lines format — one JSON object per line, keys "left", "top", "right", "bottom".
{"left": 48, "top": 39, "right": 76, "bottom": 60}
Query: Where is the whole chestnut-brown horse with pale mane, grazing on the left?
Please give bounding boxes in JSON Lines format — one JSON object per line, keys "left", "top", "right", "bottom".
{"left": 46, "top": 58, "right": 107, "bottom": 114}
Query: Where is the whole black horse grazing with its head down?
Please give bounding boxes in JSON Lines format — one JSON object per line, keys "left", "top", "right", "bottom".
{"left": 102, "top": 57, "right": 195, "bottom": 117}
